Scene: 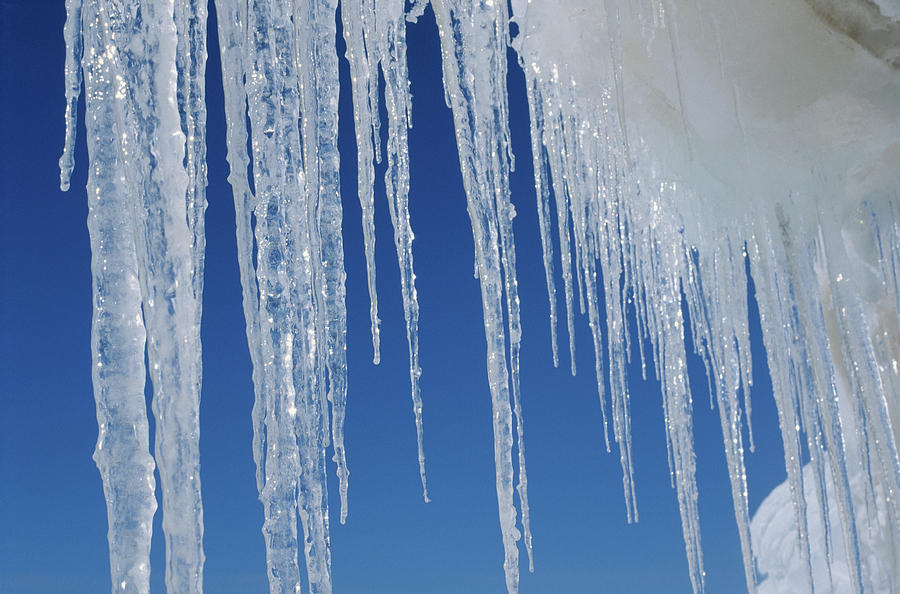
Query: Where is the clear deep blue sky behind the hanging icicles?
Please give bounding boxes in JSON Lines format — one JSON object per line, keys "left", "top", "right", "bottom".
{"left": 0, "top": 0, "right": 784, "bottom": 593}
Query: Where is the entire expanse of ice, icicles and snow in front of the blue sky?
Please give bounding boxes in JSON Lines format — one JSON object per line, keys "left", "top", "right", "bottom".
{"left": 60, "top": 0, "right": 900, "bottom": 592}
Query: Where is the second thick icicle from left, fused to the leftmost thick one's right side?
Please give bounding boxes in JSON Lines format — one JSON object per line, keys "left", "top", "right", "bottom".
{"left": 91, "top": 2, "right": 205, "bottom": 592}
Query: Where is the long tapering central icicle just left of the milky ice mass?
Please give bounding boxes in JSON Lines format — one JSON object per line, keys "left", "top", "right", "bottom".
{"left": 432, "top": 0, "right": 529, "bottom": 592}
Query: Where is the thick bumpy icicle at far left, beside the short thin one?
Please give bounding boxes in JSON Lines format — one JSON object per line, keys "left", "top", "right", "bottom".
{"left": 80, "top": 1, "right": 156, "bottom": 594}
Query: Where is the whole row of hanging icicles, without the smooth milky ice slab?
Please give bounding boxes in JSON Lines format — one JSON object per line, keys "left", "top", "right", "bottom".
{"left": 61, "top": 0, "right": 900, "bottom": 592}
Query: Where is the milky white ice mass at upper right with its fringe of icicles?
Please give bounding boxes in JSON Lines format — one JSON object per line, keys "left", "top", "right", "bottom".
{"left": 513, "top": 1, "right": 900, "bottom": 590}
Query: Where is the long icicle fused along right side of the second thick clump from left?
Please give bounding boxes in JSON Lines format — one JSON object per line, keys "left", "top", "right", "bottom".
{"left": 293, "top": 0, "right": 349, "bottom": 592}
